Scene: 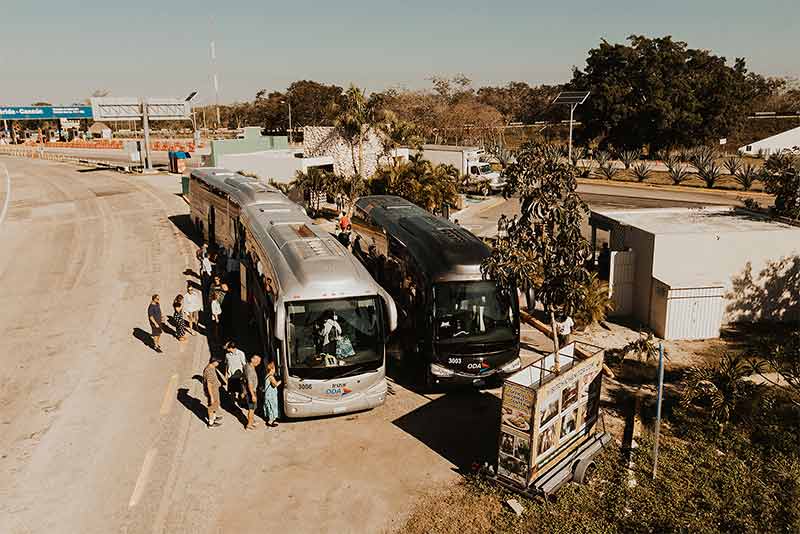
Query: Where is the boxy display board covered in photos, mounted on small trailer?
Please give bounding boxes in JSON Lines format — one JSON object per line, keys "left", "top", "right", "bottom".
{"left": 497, "top": 343, "right": 603, "bottom": 487}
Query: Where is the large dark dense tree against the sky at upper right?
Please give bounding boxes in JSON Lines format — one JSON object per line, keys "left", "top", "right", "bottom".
{"left": 571, "top": 35, "right": 772, "bottom": 151}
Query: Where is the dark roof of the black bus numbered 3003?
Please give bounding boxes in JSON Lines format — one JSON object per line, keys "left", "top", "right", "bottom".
{"left": 356, "top": 195, "right": 491, "bottom": 282}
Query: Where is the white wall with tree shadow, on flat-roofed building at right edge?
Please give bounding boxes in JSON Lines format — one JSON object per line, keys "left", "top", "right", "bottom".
{"left": 652, "top": 228, "right": 800, "bottom": 322}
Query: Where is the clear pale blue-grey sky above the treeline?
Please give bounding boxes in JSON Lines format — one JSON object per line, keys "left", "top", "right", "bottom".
{"left": 0, "top": 0, "right": 800, "bottom": 105}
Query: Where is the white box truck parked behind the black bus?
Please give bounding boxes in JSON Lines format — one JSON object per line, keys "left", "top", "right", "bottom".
{"left": 418, "top": 145, "right": 506, "bottom": 194}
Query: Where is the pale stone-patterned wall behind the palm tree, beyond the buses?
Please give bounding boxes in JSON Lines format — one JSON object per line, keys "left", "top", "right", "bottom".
{"left": 303, "top": 126, "right": 383, "bottom": 178}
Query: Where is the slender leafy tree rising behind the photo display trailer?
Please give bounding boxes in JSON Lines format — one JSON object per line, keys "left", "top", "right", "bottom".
{"left": 482, "top": 143, "right": 591, "bottom": 371}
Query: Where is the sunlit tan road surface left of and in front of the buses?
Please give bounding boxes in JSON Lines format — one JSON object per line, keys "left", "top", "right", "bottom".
{"left": 0, "top": 158, "right": 560, "bottom": 534}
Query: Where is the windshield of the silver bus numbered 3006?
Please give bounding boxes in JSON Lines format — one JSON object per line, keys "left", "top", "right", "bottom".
{"left": 286, "top": 296, "right": 383, "bottom": 379}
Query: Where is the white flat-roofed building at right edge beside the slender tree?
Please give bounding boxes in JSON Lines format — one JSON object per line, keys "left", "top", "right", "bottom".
{"left": 589, "top": 207, "right": 800, "bottom": 339}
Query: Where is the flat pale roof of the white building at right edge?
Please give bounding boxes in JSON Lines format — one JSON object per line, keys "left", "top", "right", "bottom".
{"left": 591, "top": 207, "right": 800, "bottom": 235}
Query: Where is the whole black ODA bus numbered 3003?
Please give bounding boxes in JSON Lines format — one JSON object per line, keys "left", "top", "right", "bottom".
{"left": 351, "top": 195, "right": 521, "bottom": 387}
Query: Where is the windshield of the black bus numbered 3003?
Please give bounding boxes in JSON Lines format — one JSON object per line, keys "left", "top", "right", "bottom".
{"left": 433, "top": 281, "right": 516, "bottom": 341}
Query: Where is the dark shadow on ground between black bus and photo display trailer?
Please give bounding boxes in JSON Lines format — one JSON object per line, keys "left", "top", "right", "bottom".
{"left": 392, "top": 391, "right": 500, "bottom": 474}
